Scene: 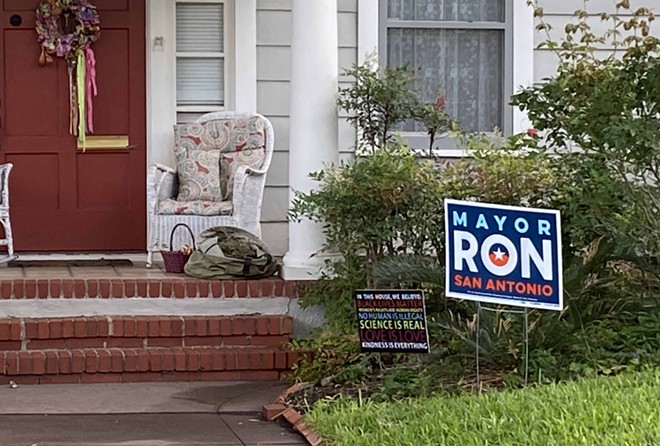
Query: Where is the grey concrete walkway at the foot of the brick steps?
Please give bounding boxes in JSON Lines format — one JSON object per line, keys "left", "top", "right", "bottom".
{"left": 0, "top": 383, "right": 306, "bottom": 446}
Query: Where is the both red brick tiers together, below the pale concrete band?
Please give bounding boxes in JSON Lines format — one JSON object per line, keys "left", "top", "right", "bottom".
{"left": 0, "top": 315, "right": 300, "bottom": 384}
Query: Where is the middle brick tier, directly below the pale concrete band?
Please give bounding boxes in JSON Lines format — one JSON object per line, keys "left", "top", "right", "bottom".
{"left": 0, "top": 315, "right": 293, "bottom": 351}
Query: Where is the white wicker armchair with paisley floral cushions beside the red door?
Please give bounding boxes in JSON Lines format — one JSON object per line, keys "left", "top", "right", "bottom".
{"left": 147, "top": 112, "right": 274, "bottom": 266}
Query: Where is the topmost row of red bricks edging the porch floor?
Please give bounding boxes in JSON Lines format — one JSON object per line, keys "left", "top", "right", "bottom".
{"left": 0, "top": 278, "right": 306, "bottom": 299}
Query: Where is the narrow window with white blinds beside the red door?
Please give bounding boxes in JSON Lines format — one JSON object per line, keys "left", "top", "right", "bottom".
{"left": 175, "top": 0, "right": 230, "bottom": 122}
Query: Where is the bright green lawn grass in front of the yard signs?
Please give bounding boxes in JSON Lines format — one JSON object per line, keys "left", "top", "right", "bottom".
{"left": 307, "top": 369, "right": 660, "bottom": 446}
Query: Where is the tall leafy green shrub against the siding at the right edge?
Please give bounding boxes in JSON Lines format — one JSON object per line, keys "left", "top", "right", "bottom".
{"left": 512, "top": 0, "right": 660, "bottom": 258}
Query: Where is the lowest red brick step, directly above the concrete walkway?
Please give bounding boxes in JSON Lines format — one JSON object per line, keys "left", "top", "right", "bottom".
{"left": 0, "top": 346, "right": 301, "bottom": 384}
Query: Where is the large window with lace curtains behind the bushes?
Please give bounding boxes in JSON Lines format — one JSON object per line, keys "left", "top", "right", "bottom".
{"left": 380, "top": 0, "right": 513, "bottom": 139}
